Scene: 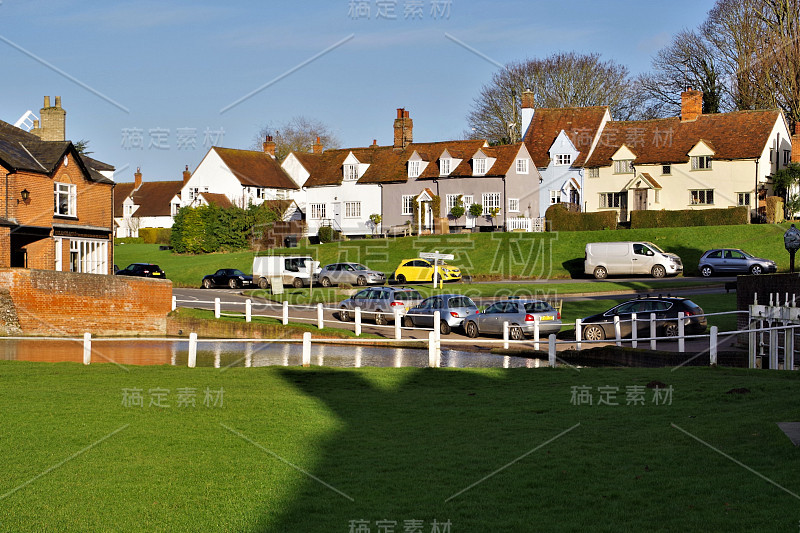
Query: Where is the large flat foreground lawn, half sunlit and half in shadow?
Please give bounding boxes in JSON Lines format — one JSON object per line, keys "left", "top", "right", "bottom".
{"left": 0, "top": 361, "right": 800, "bottom": 533}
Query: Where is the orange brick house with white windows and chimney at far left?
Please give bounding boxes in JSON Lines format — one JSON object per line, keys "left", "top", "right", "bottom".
{"left": 0, "top": 97, "right": 114, "bottom": 274}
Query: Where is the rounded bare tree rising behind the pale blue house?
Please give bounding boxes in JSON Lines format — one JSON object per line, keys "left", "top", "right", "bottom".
{"left": 465, "top": 52, "right": 641, "bottom": 143}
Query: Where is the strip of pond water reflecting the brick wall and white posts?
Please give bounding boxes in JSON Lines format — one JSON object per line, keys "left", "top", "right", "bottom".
{"left": 0, "top": 339, "right": 546, "bottom": 368}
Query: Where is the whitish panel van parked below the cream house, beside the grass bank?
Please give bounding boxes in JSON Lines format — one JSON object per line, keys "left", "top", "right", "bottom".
{"left": 583, "top": 242, "right": 683, "bottom": 279}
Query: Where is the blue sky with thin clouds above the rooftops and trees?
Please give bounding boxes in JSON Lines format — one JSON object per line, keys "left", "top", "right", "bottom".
{"left": 0, "top": 0, "right": 714, "bottom": 181}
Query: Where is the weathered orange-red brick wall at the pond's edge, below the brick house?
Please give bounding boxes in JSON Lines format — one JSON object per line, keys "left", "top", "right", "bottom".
{"left": 0, "top": 268, "right": 172, "bottom": 336}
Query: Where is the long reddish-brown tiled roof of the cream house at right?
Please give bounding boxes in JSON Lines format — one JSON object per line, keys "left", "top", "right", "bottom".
{"left": 585, "top": 110, "right": 782, "bottom": 167}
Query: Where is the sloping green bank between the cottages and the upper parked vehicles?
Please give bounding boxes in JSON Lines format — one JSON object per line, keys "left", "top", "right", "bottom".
{"left": 114, "top": 224, "right": 789, "bottom": 287}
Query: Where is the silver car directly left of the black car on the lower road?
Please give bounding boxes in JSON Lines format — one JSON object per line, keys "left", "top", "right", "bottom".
{"left": 464, "top": 299, "right": 561, "bottom": 340}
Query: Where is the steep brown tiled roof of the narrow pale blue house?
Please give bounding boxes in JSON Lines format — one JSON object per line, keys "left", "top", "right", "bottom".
{"left": 523, "top": 106, "right": 608, "bottom": 168}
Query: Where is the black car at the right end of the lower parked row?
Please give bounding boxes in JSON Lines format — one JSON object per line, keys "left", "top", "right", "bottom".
{"left": 581, "top": 296, "right": 707, "bottom": 341}
